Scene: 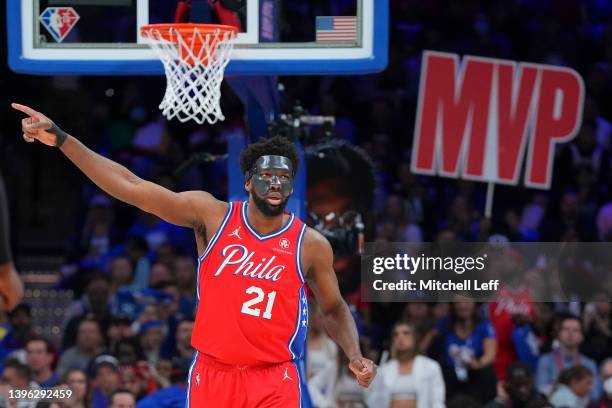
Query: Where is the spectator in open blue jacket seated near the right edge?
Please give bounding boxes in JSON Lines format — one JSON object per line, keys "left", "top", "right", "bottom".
{"left": 536, "top": 315, "right": 601, "bottom": 400}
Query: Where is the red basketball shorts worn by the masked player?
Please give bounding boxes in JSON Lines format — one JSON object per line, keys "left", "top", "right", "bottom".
{"left": 186, "top": 352, "right": 310, "bottom": 408}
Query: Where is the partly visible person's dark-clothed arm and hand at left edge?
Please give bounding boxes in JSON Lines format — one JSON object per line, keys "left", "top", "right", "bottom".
{"left": 0, "top": 171, "right": 23, "bottom": 310}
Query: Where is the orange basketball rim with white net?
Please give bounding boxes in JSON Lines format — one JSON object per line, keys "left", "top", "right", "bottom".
{"left": 140, "top": 24, "right": 238, "bottom": 124}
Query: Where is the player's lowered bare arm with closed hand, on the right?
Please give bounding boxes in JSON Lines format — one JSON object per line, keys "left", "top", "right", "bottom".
{"left": 303, "top": 228, "right": 376, "bottom": 387}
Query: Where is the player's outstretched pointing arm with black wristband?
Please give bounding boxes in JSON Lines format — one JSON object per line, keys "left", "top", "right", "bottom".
{"left": 11, "top": 103, "right": 223, "bottom": 227}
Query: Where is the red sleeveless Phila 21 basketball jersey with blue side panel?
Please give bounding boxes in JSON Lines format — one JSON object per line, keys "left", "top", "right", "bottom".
{"left": 191, "top": 202, "right": 308, "bottom": 365}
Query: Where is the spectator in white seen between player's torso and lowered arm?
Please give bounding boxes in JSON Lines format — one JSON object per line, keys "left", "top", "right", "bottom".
{"left": 306, "top": 301, "right": 338, "bottom": 378}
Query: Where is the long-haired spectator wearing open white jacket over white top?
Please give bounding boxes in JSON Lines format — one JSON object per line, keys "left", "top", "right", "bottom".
{"left": 367, "top": 322, "right": 445, "bottom": 408}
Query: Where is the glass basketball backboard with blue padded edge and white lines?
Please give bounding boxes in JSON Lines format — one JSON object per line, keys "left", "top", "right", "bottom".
{"left": 7, "top": 0, "right": 388, "bottom": 75}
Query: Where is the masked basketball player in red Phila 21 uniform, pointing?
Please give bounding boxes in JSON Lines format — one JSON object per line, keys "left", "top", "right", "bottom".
{"left": 12, "top": 104, "right": 376, "bottom": 408}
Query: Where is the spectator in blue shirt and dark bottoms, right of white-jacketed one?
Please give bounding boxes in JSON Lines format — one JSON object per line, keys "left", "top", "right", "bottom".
{"left": 438, "top": 296, "right": 497, "bottom": 403}
